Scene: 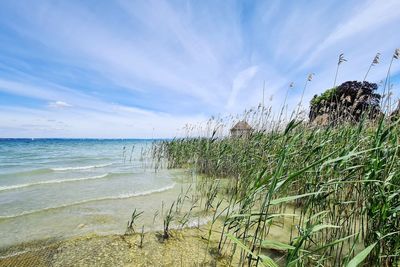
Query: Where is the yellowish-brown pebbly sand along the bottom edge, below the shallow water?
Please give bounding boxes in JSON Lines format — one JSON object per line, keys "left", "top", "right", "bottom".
{"left": 0, "top": 227, "right": 236, "bottom": 266}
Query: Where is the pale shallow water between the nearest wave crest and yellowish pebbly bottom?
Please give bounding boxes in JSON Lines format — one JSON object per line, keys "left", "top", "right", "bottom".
{"left": 0, "top": 169, "right": 197, "bottom": 251}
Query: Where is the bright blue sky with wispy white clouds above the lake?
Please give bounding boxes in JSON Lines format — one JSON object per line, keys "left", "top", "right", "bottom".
{"left": 0, "top": 0, "right": 400, "bottom": 138}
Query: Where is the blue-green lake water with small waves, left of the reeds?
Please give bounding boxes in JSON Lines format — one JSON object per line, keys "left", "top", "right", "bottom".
{"left": 0, "top": 139, "right": 188, "bottom": 250}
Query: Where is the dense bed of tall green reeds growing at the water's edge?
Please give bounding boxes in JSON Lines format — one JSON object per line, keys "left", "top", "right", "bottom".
{"left": 154, "top": 115, "right": 400, "bottom": 266}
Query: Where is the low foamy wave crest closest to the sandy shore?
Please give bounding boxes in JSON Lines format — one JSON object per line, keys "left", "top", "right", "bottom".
{"left": 0, "top": 183, "right": 175, "bottom": 220}
